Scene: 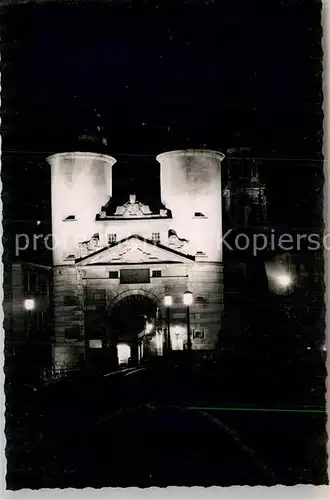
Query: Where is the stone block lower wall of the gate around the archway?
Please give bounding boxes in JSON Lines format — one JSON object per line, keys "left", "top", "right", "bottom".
{"left": 54, "top": 262, "right": 223, "bottom": 367}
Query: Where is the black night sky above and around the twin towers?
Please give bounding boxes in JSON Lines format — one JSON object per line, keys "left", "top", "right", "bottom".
{"left": 2, "top": 0, "right": 323, "bottom": 262}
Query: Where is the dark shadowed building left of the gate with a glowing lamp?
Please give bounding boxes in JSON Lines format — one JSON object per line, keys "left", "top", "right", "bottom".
{"left": 3, "top": 262, "right": 53, "bottom": 382}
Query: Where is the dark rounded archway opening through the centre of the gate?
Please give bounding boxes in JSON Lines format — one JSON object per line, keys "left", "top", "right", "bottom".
{"left": 110, "top": 293, "right": 159, "bottom": 363}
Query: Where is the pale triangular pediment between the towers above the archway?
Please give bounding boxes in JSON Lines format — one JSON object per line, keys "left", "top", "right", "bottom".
{"left": 76, "top": 235, "right": 194, "bottom": 266}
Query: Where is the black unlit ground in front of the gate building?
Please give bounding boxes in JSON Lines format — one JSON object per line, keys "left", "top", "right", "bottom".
{"left": 6, "top": 356, "right": 328, "bottom": 489}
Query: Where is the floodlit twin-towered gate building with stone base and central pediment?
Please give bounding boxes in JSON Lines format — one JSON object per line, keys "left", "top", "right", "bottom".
{"left": 48, "top": 146, "right": 224, "bottom": 369}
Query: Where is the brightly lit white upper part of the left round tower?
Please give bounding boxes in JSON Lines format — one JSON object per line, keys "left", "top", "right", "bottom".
{"left": 47, "top": 152, "right": 116, "bottom": 265}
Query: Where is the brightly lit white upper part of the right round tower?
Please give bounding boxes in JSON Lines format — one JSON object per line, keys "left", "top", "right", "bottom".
{"left": 157, "top": 149, "right": 224, "bottom": 262}
